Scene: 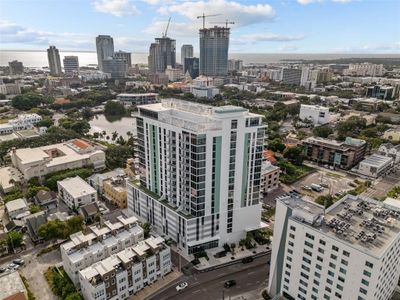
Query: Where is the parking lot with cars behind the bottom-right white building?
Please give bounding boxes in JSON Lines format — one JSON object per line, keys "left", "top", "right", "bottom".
{"left": 291, "top": 170, "right": 355, "bottom": 198}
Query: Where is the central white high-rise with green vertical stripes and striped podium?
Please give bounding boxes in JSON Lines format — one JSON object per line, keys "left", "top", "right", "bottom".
{"left": 127, "top": 99, "right": 265, "bottom": 254}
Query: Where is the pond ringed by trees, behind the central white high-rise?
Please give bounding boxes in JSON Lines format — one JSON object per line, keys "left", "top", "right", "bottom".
{"left": 89, "top": 114, "right": 136, "bottom": 139}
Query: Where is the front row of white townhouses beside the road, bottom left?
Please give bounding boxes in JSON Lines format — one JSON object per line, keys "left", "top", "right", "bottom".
{"left": 79, "top": 237, "right": 171, "bottom": 300}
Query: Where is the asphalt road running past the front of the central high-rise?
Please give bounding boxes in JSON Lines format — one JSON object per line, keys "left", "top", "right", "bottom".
{"left": 147, "top": 254, "right": 270, "bottom": 300}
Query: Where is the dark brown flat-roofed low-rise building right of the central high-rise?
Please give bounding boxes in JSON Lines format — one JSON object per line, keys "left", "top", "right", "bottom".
{"left": 303, "top": 137, "right": 367, "bottom": 170}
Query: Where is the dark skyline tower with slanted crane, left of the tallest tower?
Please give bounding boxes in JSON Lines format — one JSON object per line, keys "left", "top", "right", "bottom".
{"left": 148, "top": 37, "right": 176, "bottom": 74}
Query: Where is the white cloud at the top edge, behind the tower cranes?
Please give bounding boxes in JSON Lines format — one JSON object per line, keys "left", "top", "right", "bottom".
{"left": 158, "top": 0, "right": 275, "bottom": 27}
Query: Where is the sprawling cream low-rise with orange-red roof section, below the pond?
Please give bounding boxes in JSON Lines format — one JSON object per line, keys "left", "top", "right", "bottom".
{"left": 11, "top": 139, "right": 106, "bottom": 180}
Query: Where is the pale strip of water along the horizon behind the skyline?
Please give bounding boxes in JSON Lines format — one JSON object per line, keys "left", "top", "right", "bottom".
{"left": 0, "top": 50, "right": 400, "bottom": 68}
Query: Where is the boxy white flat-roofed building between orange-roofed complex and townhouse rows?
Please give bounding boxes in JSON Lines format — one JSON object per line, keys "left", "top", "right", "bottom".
{"left": 57, "top": 176, "right": 97, "bottom": 209}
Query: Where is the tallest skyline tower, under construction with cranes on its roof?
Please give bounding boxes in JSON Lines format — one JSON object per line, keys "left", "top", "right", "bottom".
{"left": 200, "top": 26, "right": 230, "bottom": 76}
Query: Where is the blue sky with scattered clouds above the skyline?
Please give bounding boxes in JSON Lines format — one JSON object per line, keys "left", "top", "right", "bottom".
{"left": 0, "top": 0, "right": 400, "bottom": 53}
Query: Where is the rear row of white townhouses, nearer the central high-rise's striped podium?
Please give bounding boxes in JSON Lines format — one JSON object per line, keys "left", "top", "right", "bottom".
{"left": 60, "top": 216, "right": 143, "bottom": 287}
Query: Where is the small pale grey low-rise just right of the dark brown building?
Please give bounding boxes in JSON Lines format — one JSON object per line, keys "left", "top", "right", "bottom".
{"left": 352, "top": 154, "right": 394, "bottom": 178}
